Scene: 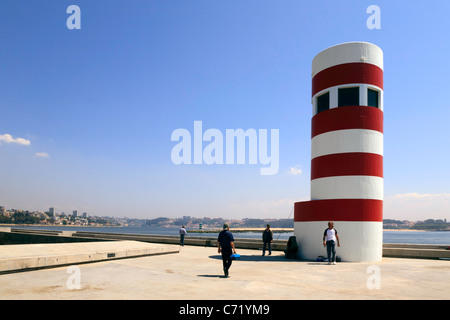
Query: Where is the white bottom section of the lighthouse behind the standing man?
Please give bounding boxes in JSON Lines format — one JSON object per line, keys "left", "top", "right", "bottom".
{"left": 294, "top": 221, "right": 383, "bottom": 262}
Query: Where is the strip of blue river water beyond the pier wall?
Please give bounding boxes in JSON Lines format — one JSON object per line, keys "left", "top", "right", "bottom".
{"left": 7, "top": 226, "right": 450, "bottom": 246}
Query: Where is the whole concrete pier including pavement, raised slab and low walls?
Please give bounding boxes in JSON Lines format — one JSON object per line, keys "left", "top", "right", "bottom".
{"left": 0, "top": 230, "right": 450, "bottom": 300}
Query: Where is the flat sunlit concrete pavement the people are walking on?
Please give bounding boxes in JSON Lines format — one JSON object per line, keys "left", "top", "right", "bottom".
{"left": 0, "top": 244, "right": 450, "bottom": 300}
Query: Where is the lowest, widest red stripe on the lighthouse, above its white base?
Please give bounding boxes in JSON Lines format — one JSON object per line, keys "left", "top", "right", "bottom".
{"left": 294, "top": 199, "right": 383, "bottom": 222}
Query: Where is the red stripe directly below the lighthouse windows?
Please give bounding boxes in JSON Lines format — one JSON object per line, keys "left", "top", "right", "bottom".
{"left": 311, "top": 106, "right": 383, "bottom": 138}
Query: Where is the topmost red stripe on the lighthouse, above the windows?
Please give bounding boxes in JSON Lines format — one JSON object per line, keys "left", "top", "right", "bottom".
{"left": 312, "top": 63, "right": 383, "bottom": 96}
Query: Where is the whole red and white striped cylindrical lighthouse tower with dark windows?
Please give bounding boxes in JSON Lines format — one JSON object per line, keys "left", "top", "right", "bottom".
{"left": 294, "top": 42, "right": 383, "bottom": 262}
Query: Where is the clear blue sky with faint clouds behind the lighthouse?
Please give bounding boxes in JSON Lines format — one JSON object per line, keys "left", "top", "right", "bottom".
{"left": 0, "top": 0, "right": 450, "bottom": 220}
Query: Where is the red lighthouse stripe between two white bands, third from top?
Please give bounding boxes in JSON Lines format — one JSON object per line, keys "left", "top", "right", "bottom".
{"left": 311, "top": 152, "right": 383, "bottom": 180}
